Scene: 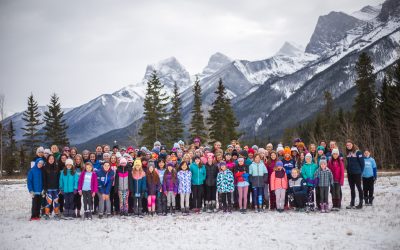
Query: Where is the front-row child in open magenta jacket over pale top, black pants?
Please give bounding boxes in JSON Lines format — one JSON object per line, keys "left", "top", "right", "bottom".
{"left": 78, "top": 162, "right": 98, "bottom": 220}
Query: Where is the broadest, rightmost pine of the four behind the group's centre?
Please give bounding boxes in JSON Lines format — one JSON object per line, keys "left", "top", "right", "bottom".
{"left": 207, "top": 79, "right": 239, "bottom": 145}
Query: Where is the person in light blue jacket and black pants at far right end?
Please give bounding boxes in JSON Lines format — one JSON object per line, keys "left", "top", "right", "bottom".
{"left": 362, "top": 149, "right": 377, "bottom": 206}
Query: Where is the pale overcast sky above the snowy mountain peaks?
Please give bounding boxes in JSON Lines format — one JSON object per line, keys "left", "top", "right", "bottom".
{"left": 0, "top": 0, "right": 383, "bottom": 115}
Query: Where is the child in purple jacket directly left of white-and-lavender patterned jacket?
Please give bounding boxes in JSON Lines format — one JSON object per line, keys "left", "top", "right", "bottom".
{"left": 163, "top": 162, "right": 178, "bottom": 214}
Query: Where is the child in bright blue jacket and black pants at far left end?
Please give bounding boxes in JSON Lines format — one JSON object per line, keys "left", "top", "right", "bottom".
{"left": 27, "top": 158, "right": 44, "bottom": 221}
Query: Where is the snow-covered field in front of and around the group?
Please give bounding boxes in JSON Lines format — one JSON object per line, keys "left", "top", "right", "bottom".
{"left": 0, "top": 176, "right": 400, "bottom": 250}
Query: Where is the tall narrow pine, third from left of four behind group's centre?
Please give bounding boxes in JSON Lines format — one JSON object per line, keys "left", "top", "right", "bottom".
{"left": 189, "top": 77, "right": 207, "bottom": 142}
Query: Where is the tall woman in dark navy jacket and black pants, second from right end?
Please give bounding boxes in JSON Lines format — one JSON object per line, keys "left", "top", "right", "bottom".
{"left": 346, "top": 139, "right": 364, "bottom": 209}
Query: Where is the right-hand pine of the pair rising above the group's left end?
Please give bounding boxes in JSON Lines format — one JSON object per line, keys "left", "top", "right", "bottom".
{"left": 43, "top": 93, "right": 69, "bottom": 146}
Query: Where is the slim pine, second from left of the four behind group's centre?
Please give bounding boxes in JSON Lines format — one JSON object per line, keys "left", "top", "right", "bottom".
{"left": 167, "top": 82, "right": 183, "bottom": 143}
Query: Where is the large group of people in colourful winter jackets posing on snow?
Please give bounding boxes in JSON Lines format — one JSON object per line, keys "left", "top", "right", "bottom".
{"left": 27, "top": 138, "right": 377, "bottom": 220}
